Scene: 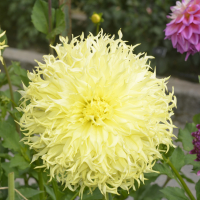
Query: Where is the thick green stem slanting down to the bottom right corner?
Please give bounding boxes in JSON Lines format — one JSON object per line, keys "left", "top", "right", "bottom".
{"left": 164, "top": 159, "right": 195, "bottom": 200}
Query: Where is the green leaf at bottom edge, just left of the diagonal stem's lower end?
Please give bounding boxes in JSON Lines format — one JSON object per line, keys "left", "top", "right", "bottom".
{"left": 160, "top": 187, "right": 188, "bottom": 200}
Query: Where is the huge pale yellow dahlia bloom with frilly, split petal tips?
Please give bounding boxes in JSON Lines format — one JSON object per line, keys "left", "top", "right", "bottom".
{"left": 18, "top": 31, "right": 176, "bottom": 195}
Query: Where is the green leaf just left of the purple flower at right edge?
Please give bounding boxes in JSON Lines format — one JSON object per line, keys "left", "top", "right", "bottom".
{"left": 177, "top": 123, "right": 197, "bottom": 151}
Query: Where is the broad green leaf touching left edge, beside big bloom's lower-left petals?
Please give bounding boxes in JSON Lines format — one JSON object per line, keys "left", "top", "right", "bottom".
{"left": 0, "top": 121, "right": 21, "bottom": 151}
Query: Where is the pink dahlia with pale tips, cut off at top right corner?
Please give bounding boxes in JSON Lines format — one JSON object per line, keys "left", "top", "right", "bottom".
{"left": 164, "top": 0, "right": 200, "bottom": 60}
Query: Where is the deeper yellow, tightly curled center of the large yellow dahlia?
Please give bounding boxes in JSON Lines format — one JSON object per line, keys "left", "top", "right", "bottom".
{"left": 83, "top": 98, "right": 112, "bottom": 125}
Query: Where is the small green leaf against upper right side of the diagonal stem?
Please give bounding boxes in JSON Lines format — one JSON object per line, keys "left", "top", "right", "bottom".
{"left": 170, "top": 147, "right": 185, "bottom": 171}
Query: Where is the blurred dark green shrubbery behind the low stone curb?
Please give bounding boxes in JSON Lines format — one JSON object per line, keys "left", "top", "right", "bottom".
{"left": 0, "top": 0, "right": 200, "bottom": 82}
